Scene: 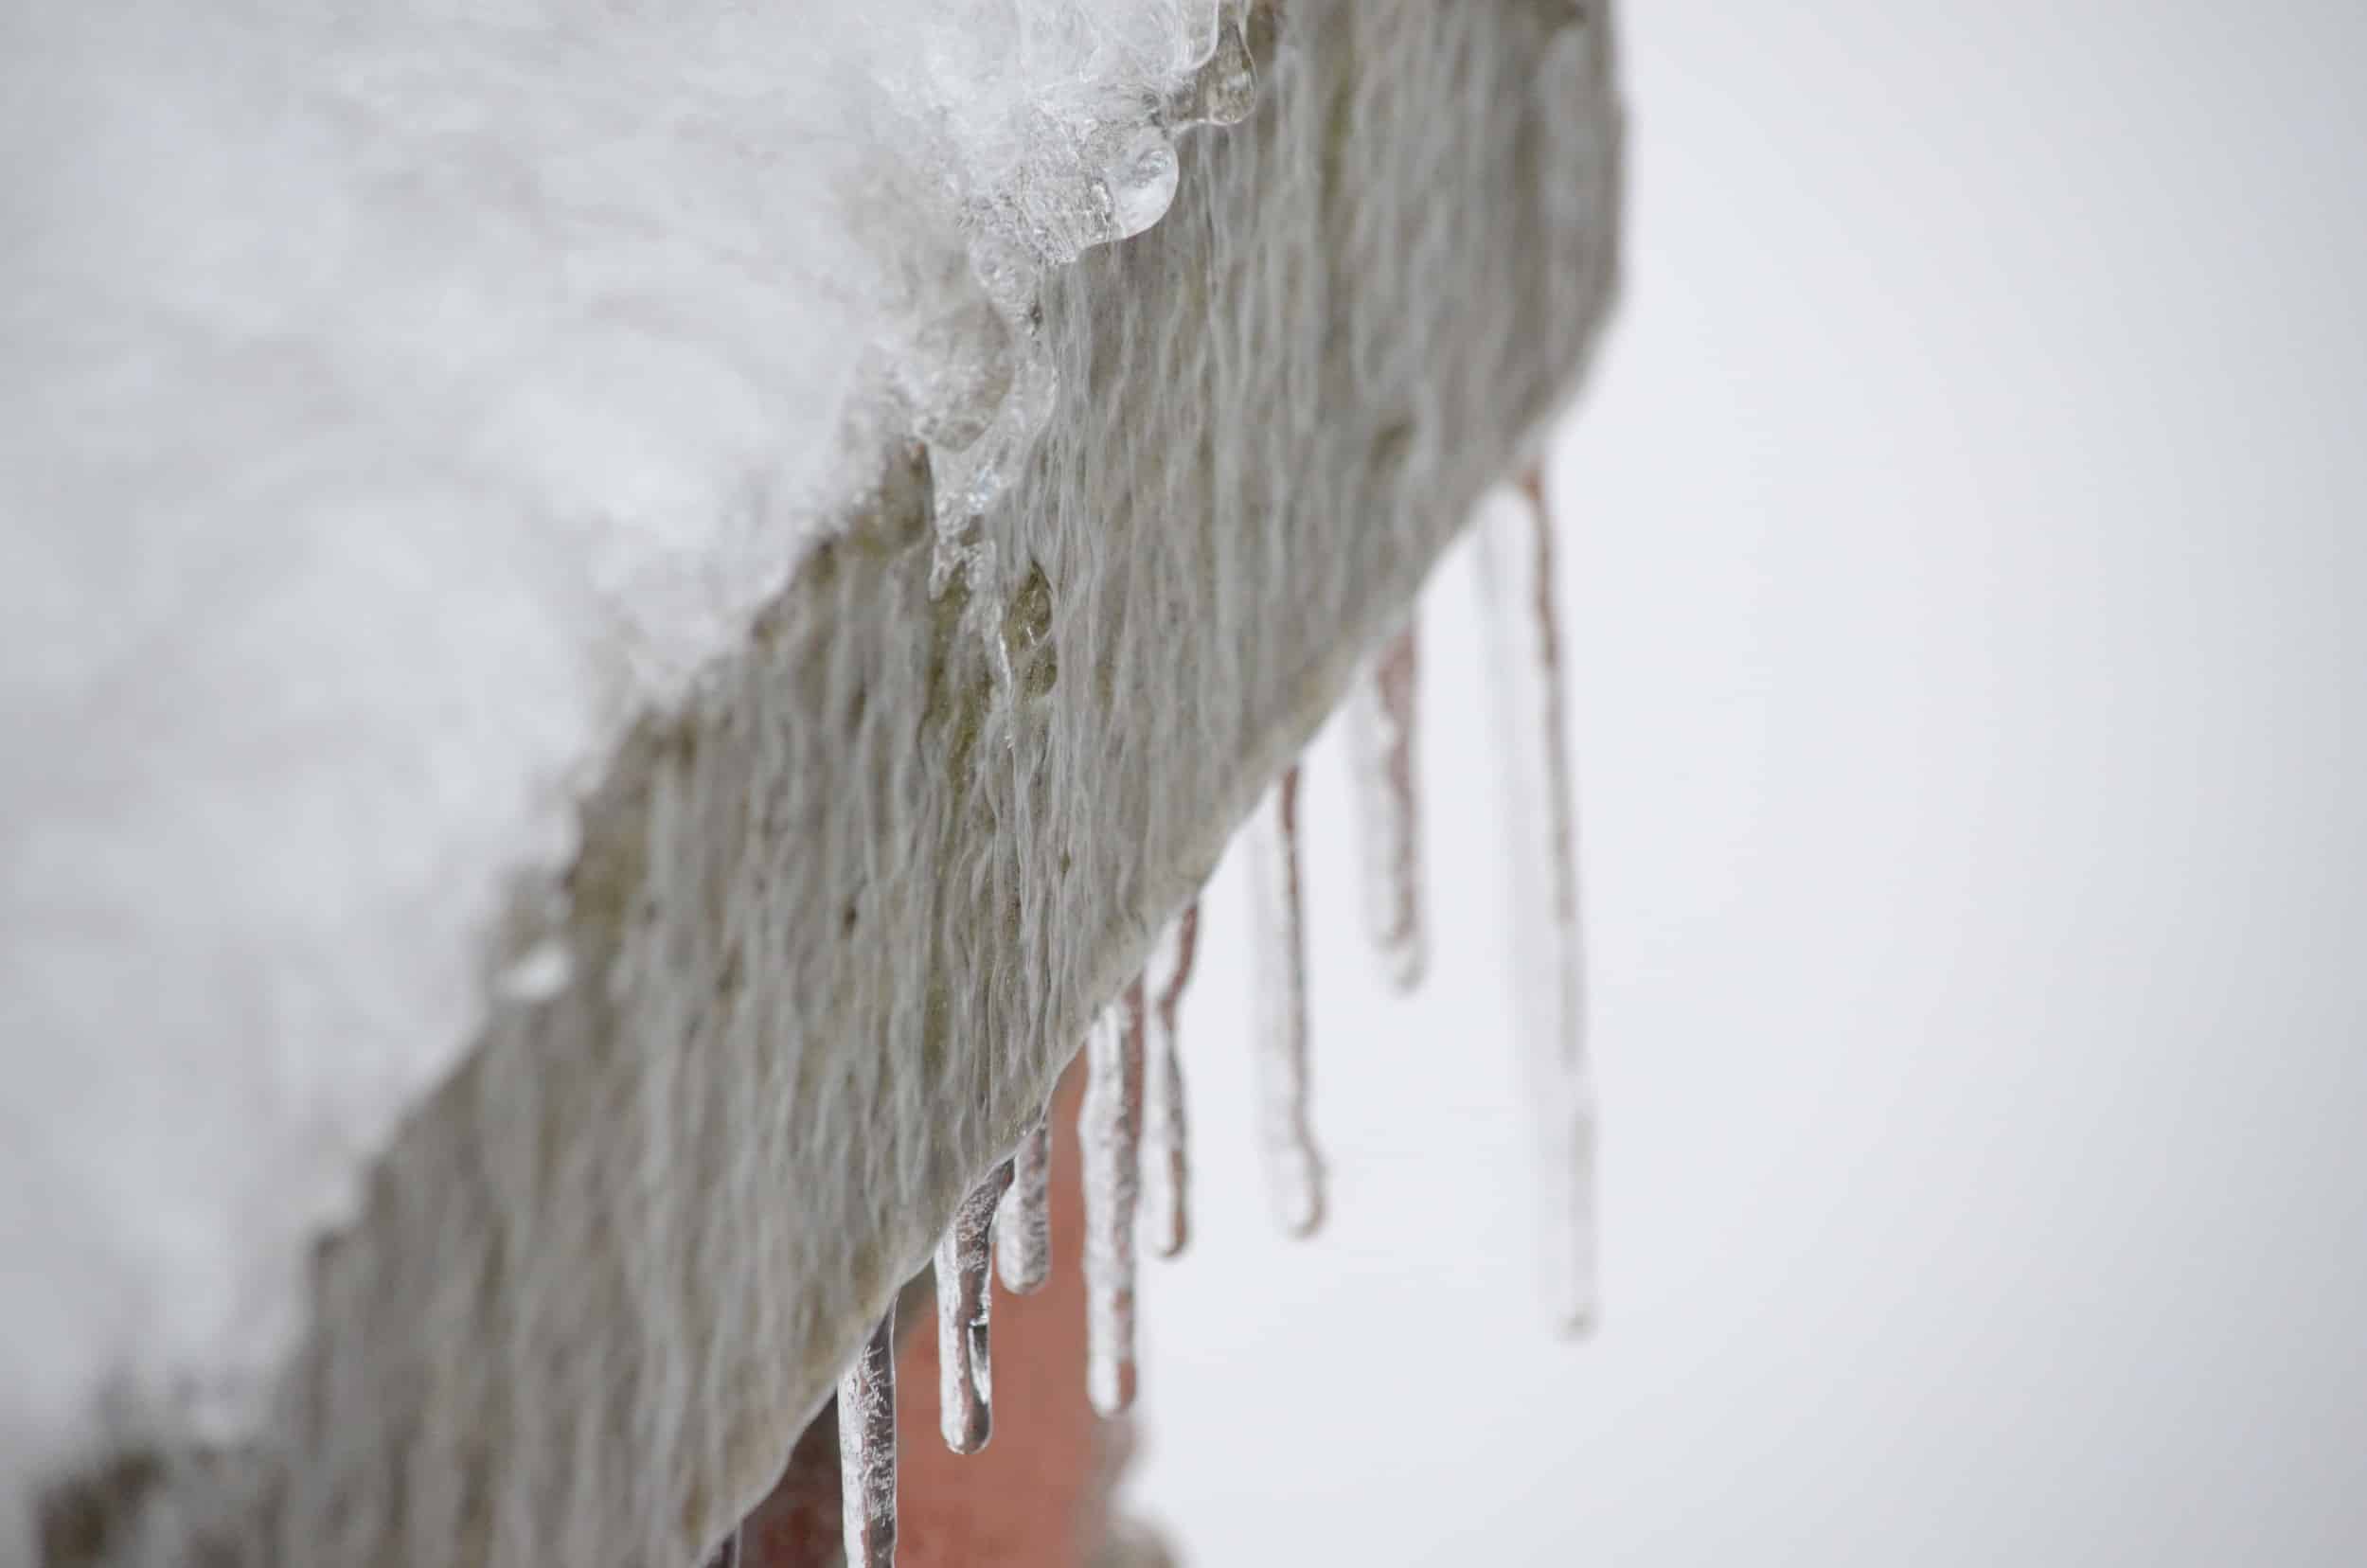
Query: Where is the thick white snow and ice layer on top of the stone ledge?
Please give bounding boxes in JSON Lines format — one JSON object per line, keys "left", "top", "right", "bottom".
{"left": 0, "top": 0, "right": 1278, "bottom": 1515}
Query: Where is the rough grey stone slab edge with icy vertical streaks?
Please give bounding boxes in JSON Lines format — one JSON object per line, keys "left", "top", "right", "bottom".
{"left": 45, "top": 0, "right": 1619, "bottom": 1568}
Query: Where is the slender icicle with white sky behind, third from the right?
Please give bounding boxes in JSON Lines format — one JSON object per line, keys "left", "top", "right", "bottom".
{"left": 1250, "top": 762, "right": 1324, "bottom": 1237}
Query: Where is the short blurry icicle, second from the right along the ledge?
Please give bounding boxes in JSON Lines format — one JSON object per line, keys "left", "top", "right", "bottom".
{"left": 1349, "top": 615, "right": 1428, "bottom": 990}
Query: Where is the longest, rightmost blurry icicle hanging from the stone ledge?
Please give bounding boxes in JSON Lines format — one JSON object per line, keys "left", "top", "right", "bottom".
{"left": 1485, "top": 472, "right": 1598, "bottom": 1333}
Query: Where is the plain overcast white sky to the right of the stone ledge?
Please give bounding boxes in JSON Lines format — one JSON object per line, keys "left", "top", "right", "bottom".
{"left": 1136, "top": 0, "right": 2367, "bottom": 1568}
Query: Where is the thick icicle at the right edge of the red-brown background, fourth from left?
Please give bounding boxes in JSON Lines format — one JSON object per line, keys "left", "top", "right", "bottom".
{"left": 1077, "top": 978, "right": 1144, "bottom": 1417}
